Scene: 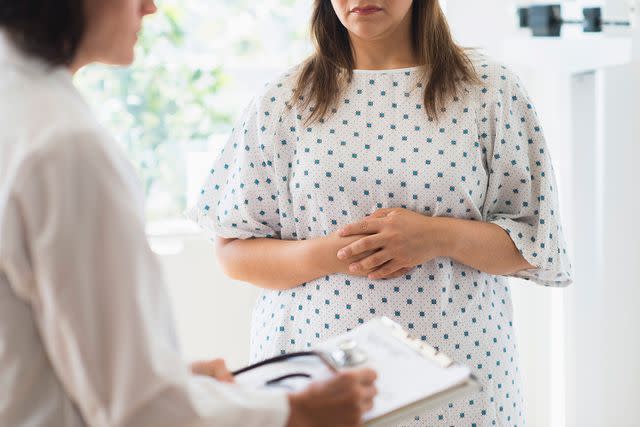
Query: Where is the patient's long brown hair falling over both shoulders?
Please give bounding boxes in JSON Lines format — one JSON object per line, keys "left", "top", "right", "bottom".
{"left": 293, "top": 0, "right": 478, "bottom": 122}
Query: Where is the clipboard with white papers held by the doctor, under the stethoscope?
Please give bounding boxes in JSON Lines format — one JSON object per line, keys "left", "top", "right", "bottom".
{"left": 236, "top": 317, "right": 482, "bottom": 427}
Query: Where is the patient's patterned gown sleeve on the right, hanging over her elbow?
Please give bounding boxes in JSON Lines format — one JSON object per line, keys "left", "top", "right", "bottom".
{"left": 480, "top": 66, "right": 572, "bottom": 287}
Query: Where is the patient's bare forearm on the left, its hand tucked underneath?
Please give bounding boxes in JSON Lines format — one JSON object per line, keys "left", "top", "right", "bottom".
{"left": 216, "top": 233, "right": 406, "bottom": 290}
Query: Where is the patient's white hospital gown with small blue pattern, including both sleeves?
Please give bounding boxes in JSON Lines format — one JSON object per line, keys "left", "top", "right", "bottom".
{"left": 191, "top": 55, "right": 571, "bottom": 426}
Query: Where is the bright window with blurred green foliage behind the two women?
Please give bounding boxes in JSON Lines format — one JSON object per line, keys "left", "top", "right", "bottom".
{"left": 77, "top": 0, "right": 311, "bottom": 222}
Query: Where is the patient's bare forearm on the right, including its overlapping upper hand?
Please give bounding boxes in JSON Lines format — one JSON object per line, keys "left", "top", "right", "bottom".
{"left": 338, "top": 209, "right": 535, "bottom": 279}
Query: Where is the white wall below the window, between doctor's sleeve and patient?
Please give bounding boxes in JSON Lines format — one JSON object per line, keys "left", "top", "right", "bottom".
{"left": 151, "top": 236, "right": 258, "bottom": 368}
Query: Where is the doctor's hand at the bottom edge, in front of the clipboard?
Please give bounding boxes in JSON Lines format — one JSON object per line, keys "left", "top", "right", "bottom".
{"left": 287, "top": 369, "right": 378, "bottom": 427}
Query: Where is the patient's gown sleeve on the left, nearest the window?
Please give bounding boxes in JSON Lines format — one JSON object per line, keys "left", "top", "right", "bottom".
{"left": 187, "top": 98, "right": 282, "bottom": 244}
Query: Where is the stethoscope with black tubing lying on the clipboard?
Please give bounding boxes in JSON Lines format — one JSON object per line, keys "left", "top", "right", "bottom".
{"left": 232, "top": 339, "right": 367, "bottom": 386}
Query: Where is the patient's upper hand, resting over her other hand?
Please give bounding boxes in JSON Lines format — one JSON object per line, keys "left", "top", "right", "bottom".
{"left": 338, "top": 208, "right": 445, "bottom": 280}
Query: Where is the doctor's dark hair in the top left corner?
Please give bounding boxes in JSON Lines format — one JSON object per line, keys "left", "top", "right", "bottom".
{"left": 0, "top": 0, "right": 85, "bottom": 65}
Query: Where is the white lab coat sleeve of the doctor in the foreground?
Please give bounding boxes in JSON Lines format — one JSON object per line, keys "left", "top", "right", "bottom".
{"left": 13, "top": 131, "right": 289, "bottom": 427}
